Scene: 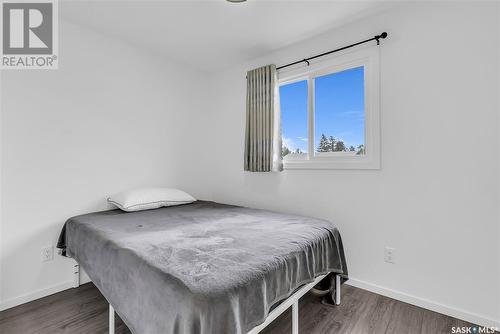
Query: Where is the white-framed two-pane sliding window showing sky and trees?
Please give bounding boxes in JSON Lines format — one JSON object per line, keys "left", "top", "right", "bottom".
{"left": 279, "top": 48, "right": 380, "bottom": 169}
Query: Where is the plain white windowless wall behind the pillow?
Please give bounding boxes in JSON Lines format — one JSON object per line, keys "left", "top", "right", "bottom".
{"left": 0, "top": 21, "right": 210, "bottom": 308}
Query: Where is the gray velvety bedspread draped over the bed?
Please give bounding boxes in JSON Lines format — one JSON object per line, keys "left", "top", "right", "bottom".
{"left": 58, "top": 201, "right": 347, "bottom": 334}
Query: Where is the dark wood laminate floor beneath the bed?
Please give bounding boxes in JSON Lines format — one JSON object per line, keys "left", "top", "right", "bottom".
{"left": 0, "top": 283, "right": 473, "bottom": 334}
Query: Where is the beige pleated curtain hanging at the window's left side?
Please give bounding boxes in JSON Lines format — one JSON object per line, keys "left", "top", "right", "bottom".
{"left": 244, "top": 65, "right": 283, "bottom": 172}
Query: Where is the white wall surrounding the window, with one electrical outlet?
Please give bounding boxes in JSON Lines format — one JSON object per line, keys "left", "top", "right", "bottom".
{"left": 201, "top": 2, "right": 500, "bottom": 327}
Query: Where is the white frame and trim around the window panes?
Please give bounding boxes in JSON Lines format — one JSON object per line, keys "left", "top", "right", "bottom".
{"left": 278, "top": 46, "right": 380, "bottom": 169}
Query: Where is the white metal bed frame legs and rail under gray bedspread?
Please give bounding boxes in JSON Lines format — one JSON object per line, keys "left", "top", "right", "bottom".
{"left": 73, "top": 261, "right": 341, "bottom": 334}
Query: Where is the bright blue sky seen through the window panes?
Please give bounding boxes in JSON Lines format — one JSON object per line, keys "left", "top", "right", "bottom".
{"left": 280, "top": 67, "right": 365, "bottom": 152}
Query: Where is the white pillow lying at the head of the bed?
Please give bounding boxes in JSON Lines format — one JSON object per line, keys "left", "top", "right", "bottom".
{"left": 108, "top": 188, "right": 196, "bottom": 212}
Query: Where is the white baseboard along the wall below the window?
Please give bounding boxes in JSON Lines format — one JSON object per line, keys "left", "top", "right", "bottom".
{"left": 346, "top": 277, "right": 500, "bottom": 329}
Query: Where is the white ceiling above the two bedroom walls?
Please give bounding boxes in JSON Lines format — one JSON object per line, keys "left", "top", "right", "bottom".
{"left": 59, "top": 0, "right": 391, "bottom": 72}
